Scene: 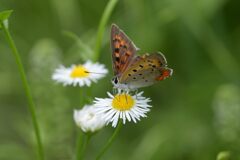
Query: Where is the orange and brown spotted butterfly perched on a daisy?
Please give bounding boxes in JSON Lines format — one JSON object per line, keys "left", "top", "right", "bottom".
{"left": 111, "top": 24, "right": 173, "bottom": 90}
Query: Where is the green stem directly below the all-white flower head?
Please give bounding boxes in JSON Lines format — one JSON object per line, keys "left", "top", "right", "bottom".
{"left": 76, "top": 132, "right": 92, "bottom": 160}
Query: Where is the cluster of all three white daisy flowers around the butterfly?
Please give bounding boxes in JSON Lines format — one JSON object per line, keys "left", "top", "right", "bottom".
{"left": 52, "top": 61, "right": 151, "bottom": 132}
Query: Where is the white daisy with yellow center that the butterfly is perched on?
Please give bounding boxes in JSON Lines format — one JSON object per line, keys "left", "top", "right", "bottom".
{"left": 94, "top": 92, "right": 151, "bottom": 127}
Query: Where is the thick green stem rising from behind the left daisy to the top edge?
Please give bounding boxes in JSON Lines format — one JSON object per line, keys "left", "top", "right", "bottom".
{"left": 93, "top": 0, "right": 118, "bottom": 61}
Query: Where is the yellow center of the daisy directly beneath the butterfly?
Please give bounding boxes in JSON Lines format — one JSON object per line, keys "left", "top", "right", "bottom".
{"left": 112, "top": 94, "right": 135, "bottom": 111}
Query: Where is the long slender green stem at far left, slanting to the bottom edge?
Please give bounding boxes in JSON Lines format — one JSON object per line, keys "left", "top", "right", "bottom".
{"left": 1, "top": 22, "right": 44, "bottom": 160}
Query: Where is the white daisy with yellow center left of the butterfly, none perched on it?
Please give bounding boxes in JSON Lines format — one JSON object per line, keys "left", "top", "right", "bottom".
{"left": 52, "top": 61, "right": 108, "bottom": 87}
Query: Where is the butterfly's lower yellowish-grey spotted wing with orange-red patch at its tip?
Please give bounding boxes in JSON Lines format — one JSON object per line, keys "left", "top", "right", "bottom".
{"left": 120, "top": 53, "right": 173, "bottom": 89}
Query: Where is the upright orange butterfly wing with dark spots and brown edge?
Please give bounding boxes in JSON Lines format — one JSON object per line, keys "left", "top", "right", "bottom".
{"left": 111, "top": 24, "right": 138, "bottom": 75}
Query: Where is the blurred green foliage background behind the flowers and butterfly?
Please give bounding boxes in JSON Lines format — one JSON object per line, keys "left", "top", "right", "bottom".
{"left": 0, "top": 0, "right": 240, "bottom": 160}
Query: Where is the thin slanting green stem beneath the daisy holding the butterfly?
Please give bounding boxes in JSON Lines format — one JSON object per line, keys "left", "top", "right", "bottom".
{"left": 96, "top": 121, "right": 122, "bottom": 160}
